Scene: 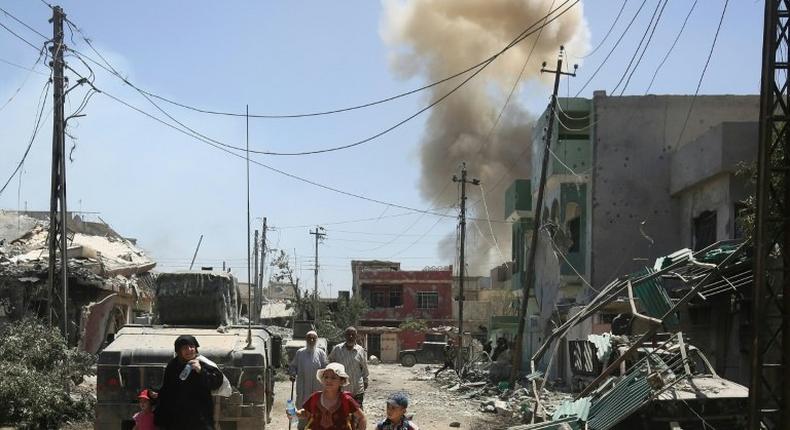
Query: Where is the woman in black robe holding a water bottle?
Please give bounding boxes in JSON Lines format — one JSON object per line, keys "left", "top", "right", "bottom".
{"left": 154, "top": 335, "right": 223, "bottom": 430}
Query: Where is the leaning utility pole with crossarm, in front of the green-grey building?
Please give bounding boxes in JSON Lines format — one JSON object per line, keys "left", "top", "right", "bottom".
{"left": 510, "top": 46, "right": 578, "bottom": 382}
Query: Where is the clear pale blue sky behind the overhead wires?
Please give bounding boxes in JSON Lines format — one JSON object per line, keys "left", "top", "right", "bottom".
{"left": 0, "top": 0, "right": 763, "bottom": 295}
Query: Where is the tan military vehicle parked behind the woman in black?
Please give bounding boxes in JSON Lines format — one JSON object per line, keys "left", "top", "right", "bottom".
{"left": 94, "top": 271, "right": 282, "bottom": 430}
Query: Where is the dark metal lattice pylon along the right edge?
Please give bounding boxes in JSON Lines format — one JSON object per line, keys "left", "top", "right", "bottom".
{"left": 748, "top": 0, "right": 790, "bottom": 430}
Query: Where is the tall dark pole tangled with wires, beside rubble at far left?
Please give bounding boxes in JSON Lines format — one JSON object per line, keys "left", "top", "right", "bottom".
{"left": 48, "top": 6, "right": 69, "bottom": 343}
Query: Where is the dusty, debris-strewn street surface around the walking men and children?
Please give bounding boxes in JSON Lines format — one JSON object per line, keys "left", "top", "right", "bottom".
{"left": 271, "top": 364, "right": 515, "bottom": 430}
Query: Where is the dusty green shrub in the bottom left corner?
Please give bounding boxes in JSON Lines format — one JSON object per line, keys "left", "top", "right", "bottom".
{"left": 0, "top": 319, "right": 95, "bottom": 429}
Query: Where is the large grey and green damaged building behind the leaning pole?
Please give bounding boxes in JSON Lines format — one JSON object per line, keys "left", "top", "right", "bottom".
{"left": 505, "top": 91, "right": 759, "bottom": 380}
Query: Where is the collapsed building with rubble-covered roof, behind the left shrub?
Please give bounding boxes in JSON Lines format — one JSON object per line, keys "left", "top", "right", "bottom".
{"left": 0, "top": 211, "right": 156, "bottom": 353}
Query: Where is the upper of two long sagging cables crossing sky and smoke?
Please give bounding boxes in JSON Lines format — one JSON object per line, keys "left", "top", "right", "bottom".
{"left": 60, "top": 0, "right": 578, "bottom": 119}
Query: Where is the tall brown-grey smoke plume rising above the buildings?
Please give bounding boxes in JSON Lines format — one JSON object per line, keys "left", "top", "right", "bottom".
{"left": 381, "top": 0, "right": 588, "bottom": 275}
